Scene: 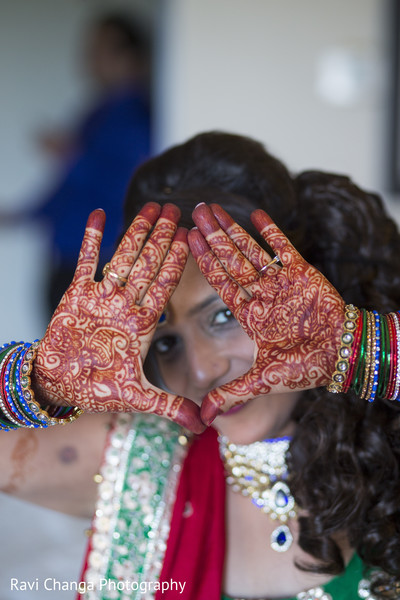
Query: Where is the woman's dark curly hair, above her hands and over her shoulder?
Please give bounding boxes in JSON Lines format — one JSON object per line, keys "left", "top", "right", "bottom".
{"left": 125, "top": 132, "right": 400, "bottom": 586}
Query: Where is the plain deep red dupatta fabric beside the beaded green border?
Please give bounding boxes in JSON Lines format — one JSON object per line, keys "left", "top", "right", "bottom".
{"left": 156, "top": 429, "right": 225, "bottom": 600}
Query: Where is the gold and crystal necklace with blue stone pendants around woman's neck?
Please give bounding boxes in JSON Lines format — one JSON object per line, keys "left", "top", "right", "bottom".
{"left": 218, "top": 435, "right": 297, "bottom": 552}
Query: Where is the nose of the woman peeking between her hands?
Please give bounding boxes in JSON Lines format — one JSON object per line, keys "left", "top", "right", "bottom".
{"left": 186, "top": 338, "right": 231, "bottom": 400}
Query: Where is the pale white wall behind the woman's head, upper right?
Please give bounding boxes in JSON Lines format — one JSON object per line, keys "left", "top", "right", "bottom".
{"left": 160, "top": 0, "right": 386, "bottom": 186}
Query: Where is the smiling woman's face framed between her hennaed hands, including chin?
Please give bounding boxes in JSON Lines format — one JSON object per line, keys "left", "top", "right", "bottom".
{"left": 151, "top": 256, "right": 297, "bottom": 443}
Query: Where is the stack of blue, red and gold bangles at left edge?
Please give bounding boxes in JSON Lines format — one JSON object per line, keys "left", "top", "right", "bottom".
{"left": 0, "top": 340, "right": 83, "bottom": 431}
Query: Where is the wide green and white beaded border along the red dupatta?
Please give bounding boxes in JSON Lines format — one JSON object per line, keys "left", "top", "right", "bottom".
{"left": 82, "top": 414, "right": 188, "bottom": 600}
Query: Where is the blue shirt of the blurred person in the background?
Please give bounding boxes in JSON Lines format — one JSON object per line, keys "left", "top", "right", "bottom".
{"left": 31, "top": 89, "right": 151, "bottom": 266}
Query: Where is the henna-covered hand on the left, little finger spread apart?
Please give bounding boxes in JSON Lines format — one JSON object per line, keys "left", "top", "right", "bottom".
{"left": 32, "top": 202, "right": 204, "bottom": 432}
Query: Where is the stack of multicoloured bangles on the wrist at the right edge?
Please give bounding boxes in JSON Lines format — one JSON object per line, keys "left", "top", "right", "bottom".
{"left": 327, "top": 304, "right": 400, "bottom": 402}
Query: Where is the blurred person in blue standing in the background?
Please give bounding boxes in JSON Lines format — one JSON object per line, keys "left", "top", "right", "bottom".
{"left": 0, "top": 13, "right": 151, "bottom": 314}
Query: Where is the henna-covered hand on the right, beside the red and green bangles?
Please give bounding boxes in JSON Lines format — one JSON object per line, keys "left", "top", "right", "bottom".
{"left": 188, "top": 204, "right": 344, "bottom": 424}
